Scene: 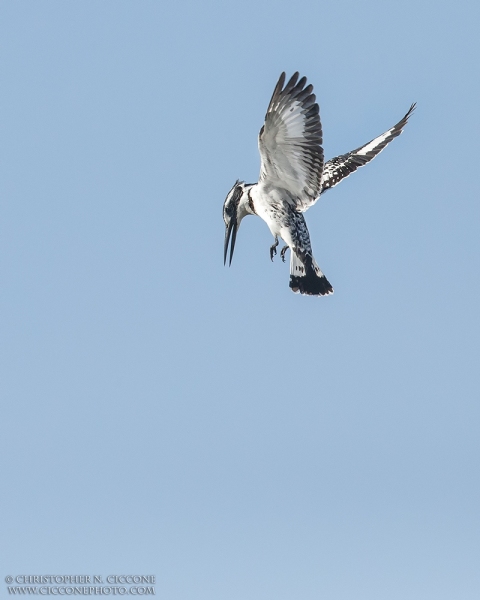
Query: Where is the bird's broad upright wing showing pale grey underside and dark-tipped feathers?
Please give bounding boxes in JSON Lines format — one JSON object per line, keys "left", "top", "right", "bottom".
{"left": 258, "top": 73, "right": 323, "bottom": 210}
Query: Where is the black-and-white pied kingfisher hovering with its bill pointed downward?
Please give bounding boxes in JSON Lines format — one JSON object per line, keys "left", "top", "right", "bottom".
{"left": 223, "top": 72, "right": 415, "bottom": 296}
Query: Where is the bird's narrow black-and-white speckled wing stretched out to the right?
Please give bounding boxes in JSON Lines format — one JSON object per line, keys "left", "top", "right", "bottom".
{"left": 320, "top": 104, "right": 415, "bottom": 194}
